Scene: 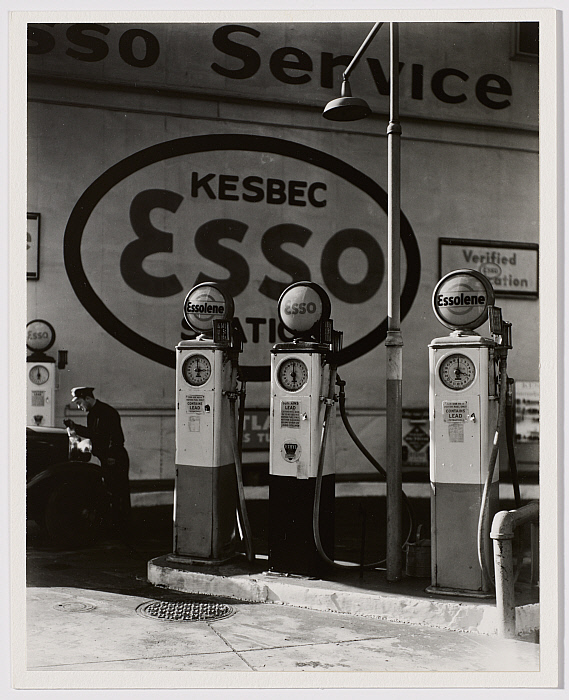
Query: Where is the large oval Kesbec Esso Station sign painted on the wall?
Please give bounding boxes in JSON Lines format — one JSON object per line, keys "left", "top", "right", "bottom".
{"left": 63, "top": 134, "right": 421, "bottom": 382}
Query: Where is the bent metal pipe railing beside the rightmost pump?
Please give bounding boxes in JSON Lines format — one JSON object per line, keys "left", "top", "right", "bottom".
{"left": 490, "top": 501, "right": 539, "bottom": 639}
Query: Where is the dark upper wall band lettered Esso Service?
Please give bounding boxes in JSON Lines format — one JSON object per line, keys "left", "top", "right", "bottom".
{"left": 28, "top": 22, "right": 537, "bottom": 127}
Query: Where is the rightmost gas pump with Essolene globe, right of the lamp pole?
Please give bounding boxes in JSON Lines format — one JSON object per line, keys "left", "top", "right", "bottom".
{"left": 427, "top": 270, "right": 511, "bottom": 597}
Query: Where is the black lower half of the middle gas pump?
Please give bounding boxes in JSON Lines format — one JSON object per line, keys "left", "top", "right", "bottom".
{"left": 269, "top": 474, "right": 336, "bottom": 577}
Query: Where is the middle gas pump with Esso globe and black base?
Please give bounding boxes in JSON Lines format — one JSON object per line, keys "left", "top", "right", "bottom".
{"left": 269, "top": 282, "right": 342, "bottom": 576}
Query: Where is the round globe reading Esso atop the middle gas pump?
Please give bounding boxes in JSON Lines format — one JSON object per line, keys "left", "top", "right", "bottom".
{"left": 277, "top": 282, "right": 330, "bottom": 337}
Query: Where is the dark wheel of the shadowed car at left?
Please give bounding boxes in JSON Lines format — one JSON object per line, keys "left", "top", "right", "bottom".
{"left": 43, "top": 478, "right": 109, "bottom": 547}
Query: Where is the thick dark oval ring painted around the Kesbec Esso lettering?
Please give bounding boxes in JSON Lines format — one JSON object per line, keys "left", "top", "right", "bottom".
{"left": 63, "top": 134, "right": 421, "bottom": 381}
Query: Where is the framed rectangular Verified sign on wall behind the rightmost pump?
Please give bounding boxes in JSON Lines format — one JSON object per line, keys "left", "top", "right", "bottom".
{"left": 439, "top": 238, "right": 539, "bottom": 298}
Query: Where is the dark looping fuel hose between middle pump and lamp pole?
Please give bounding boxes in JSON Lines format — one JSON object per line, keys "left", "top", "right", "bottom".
{"left": 312, "top": 366, "right": 413, "bottom": 569}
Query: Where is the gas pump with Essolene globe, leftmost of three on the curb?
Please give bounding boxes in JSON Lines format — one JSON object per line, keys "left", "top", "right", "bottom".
{"left": 169, "top": 282, "right": 254, "bottom": 564}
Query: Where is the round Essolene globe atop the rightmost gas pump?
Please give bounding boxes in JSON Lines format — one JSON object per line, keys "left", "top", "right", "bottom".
{"left": 433, "top": 270, "right": 494, "bottom": 330}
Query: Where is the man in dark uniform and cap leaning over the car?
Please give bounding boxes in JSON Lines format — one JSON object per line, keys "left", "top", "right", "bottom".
{"left": 63, "top": 386, "right": 130, "bottom": 532}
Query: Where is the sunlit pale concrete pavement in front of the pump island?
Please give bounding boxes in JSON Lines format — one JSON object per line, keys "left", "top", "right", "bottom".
{"left": 27, "top": 586, "right": 539, "bottom": 672}
